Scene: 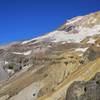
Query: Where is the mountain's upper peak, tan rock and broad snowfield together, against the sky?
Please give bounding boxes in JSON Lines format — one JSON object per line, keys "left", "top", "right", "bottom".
{"left": 22, "top": 12, "right": 100, "bottom": 44}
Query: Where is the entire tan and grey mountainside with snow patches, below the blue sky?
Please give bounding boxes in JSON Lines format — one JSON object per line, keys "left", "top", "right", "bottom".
{"left": 0, "top": 11, "right": 100, "bottom": 100}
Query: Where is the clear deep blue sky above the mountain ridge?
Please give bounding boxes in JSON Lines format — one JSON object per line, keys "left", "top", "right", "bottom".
{"left": 0, "top": 0, "right": 100, "bottom": 44}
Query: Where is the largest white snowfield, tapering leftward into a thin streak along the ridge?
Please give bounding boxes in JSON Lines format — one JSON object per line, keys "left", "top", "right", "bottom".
{"left": 22, "top": 25, "right": 100, "bottom": 44}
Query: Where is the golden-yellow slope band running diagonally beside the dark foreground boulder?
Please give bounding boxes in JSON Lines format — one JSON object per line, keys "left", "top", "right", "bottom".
{"left": 38, "top": 59, "right": 100, "bottom": 100}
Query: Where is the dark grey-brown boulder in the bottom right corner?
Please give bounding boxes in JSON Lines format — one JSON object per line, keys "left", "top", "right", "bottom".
{"left": 66, "top": 73, "right": 100, "bottom": 100}
